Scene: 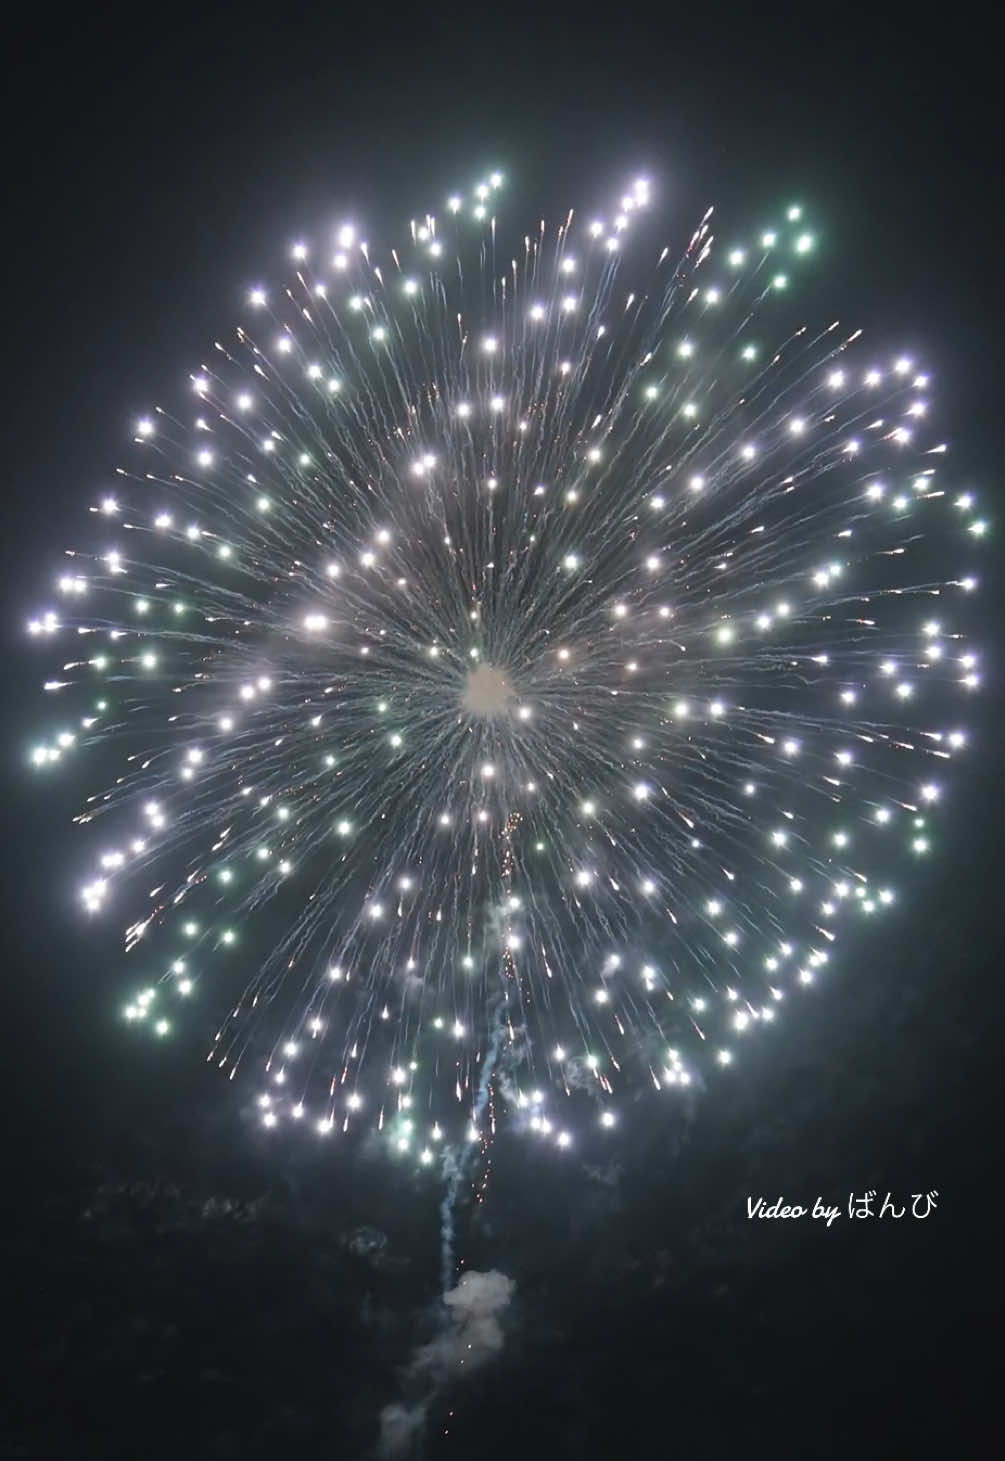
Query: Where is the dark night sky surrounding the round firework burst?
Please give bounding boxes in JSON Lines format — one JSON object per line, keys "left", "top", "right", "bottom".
{"left": 0, "top": 4, "right": 1004, "bottom": 1458}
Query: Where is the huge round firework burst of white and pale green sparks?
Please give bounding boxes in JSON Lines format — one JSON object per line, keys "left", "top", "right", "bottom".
{"left": 31, "top": 175, "right": 985, "bottom": 1163}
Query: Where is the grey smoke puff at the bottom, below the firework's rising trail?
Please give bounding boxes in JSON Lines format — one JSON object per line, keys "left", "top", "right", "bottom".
{"left": 377, "top": 1270, "right": 516, "bottom": 1461}
